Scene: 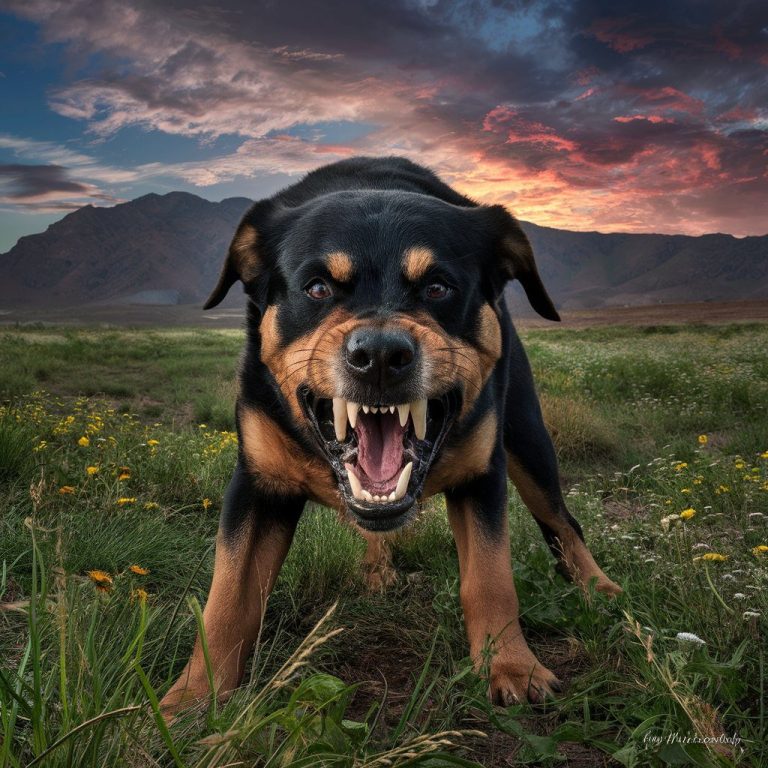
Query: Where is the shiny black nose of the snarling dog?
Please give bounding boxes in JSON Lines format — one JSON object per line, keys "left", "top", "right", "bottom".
{"left": 344, "top": 328, "right": 416, "bottom": 387}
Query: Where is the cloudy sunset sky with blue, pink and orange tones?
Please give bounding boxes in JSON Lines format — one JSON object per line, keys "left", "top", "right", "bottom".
{"left": 0, "top": 0, "right": 768, "bottom": 252}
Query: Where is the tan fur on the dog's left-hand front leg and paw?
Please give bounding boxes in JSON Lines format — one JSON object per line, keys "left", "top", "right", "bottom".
{"left": 160, "top": 522, "right": 292, "bottom": 719}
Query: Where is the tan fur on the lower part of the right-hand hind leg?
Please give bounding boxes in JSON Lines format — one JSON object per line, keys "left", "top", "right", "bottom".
{"left": 507, "top": 457, "right": 622, "bottom": 595}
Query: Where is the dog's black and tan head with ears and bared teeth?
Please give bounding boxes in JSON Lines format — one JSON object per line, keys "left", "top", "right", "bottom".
{"left": 205, "top": 190, "right": 558, "bottom": 530}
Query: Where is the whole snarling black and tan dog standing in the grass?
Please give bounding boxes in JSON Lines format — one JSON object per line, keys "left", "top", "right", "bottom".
{"left": 163, "top": 158, "right": 621, "bottom": 713}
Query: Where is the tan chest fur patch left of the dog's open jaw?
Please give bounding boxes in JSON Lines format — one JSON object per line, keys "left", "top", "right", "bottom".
{"left": 239, "top": 406, "right": 341, "bottom": 507}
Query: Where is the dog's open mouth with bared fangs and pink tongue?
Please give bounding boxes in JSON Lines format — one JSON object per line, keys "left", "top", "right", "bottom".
{"left": 299, "top": 388, "right": 457, "bottom": 531}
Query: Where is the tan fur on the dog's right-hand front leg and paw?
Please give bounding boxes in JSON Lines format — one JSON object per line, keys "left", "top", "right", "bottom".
{"left": 448, "top": 500, "right": 556, "bottom": 704}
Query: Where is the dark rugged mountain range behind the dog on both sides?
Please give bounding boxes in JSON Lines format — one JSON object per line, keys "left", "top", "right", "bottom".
{"left": 0, "top": 192, "right": 768, "bottom": 309}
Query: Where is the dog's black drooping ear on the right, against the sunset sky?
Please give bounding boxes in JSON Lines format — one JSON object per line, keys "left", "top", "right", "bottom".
{"left": 484, "top": 205, "right": 560, "bottom": 320}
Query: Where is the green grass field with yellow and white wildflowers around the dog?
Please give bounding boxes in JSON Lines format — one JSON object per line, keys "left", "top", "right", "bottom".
{"left": 0, "top": 325, "right": 768, "bottom": 768}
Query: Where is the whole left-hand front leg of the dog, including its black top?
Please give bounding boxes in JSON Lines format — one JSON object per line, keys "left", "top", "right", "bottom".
{"left": 160, "top": 465, "right": 304, "bottom": 718}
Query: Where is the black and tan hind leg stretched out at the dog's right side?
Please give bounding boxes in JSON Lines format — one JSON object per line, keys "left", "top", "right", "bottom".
{"left": 504, "top": 330, "right": 622, "bottom": 595}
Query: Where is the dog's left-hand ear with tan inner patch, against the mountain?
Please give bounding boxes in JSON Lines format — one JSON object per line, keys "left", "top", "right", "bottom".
{"left": 203, "top": 203, "right": 267, "bottom": 309}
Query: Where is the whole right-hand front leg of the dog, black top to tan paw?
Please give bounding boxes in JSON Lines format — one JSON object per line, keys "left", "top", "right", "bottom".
{"left": 446, "top": 451, "right": 560, "bottom": 704}
